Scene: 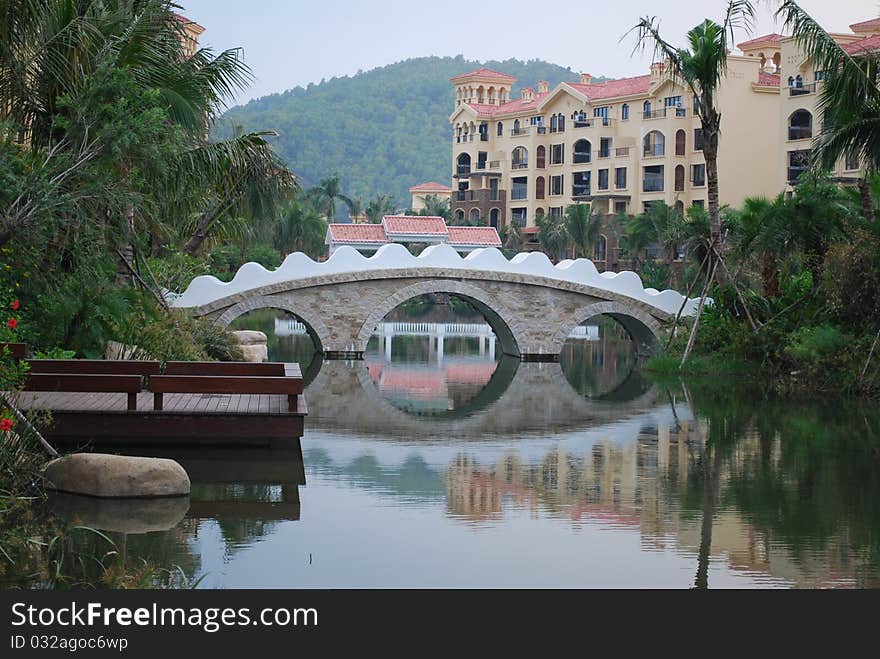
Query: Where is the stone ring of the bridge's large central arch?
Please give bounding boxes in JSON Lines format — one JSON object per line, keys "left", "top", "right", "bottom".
{"left": 355, "top": 280, "right": 520, "bottom": 357}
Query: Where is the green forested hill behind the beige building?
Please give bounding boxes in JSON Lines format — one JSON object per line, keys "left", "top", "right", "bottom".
{"left": 217, "top": 56, "right": 600, "bottom": 214}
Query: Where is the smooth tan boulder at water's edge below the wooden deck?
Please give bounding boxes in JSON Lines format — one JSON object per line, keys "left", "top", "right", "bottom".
{"left": 44, "top": 453, "right": 190, "bottom": 499}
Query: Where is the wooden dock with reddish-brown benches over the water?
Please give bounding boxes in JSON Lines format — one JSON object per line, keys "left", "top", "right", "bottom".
{"left": 12, "top": 360, "right": 307, "bottom": 447}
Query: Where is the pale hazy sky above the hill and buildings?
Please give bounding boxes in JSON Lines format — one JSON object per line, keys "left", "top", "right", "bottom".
{"left": 177, "top": 0, "right": 880, "bottom": 101}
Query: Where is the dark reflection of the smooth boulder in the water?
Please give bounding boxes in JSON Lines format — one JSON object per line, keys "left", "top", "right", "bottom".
{"left": 49, "top": 492, "right": 189, "bottom": 533}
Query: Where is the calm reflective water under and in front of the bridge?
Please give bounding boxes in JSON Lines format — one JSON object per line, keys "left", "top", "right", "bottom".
{"left": 32, "top": 307, "right": 880, "bottom": 588}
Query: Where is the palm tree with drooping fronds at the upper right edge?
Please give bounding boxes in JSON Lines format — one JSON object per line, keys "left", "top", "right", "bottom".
{"left": 776, "top": 0, "right": 880, "bottom": 222}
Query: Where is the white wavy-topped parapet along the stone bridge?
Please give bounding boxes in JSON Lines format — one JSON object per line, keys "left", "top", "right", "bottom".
{"left": 168, "top": 244, "right": 699, "bottom": 316}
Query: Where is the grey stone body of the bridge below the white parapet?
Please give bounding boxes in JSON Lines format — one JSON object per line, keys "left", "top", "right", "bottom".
{"left": 192, "top": 270, "right": 670, "bottom": 359}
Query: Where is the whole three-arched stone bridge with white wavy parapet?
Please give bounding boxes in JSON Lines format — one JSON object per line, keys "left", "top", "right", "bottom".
{"left": 172, "top": 245, "right": 697, "bottom": 358}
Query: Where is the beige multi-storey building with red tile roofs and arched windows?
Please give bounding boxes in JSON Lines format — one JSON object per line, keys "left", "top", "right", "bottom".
{"left": 450, "top": 20, "right": 880, "bottom": 240}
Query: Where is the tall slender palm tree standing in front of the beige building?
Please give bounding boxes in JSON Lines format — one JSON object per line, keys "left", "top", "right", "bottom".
{"left": 630, "top": 0, "right": 755, "bottom": 278}
